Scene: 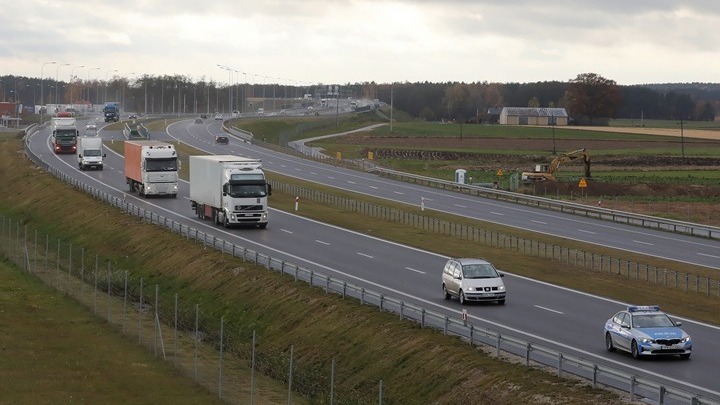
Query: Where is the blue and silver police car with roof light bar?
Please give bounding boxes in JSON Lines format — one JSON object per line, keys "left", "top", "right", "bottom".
{"left": 605, "top": 305, "right": 692, "bottom": 359}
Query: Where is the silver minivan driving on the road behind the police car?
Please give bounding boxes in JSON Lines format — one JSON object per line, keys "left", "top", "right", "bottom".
{"left": 442, "top": 258, "right": 505, "bottom": 305}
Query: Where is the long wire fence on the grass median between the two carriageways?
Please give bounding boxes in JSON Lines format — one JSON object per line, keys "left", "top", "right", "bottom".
{"left": 271, "top": 181, "right": 720, "bottom": 298}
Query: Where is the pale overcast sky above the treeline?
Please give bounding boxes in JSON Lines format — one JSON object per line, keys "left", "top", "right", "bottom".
{"left": 0, "top": 0, "right": 720, "bottom": 85}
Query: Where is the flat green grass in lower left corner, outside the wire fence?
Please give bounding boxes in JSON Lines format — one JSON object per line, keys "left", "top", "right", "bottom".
{"left": 0, "top": 260, "right": 222, "bottom": 404}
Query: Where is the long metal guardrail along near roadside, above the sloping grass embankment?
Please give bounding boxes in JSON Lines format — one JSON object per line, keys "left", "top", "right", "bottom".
{"left": 25, "top": 132, "right": 720, "bottom": 405}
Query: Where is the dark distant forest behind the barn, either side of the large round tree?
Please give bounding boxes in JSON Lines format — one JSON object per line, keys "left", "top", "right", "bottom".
{"left": 362, "top": 81, "right": 720, "bottom": 121}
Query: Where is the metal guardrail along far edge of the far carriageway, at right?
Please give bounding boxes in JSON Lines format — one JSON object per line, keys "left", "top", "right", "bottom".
{"left": 370, "top": 167, "right": 720, "bottom": 239}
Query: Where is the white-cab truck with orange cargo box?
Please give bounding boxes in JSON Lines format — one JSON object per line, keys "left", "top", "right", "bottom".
{"left": 125, "top": 141, "right": 179, "bottom": 198}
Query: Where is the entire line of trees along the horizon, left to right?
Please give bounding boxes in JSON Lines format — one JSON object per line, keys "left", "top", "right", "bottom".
{"left": 0, "top": 73, "right": 720, "bottom": 123}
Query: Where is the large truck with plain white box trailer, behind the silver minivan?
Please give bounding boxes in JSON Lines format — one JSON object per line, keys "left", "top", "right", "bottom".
{"left": 190, "top": 155, "right": 272, "bottom": 228}
